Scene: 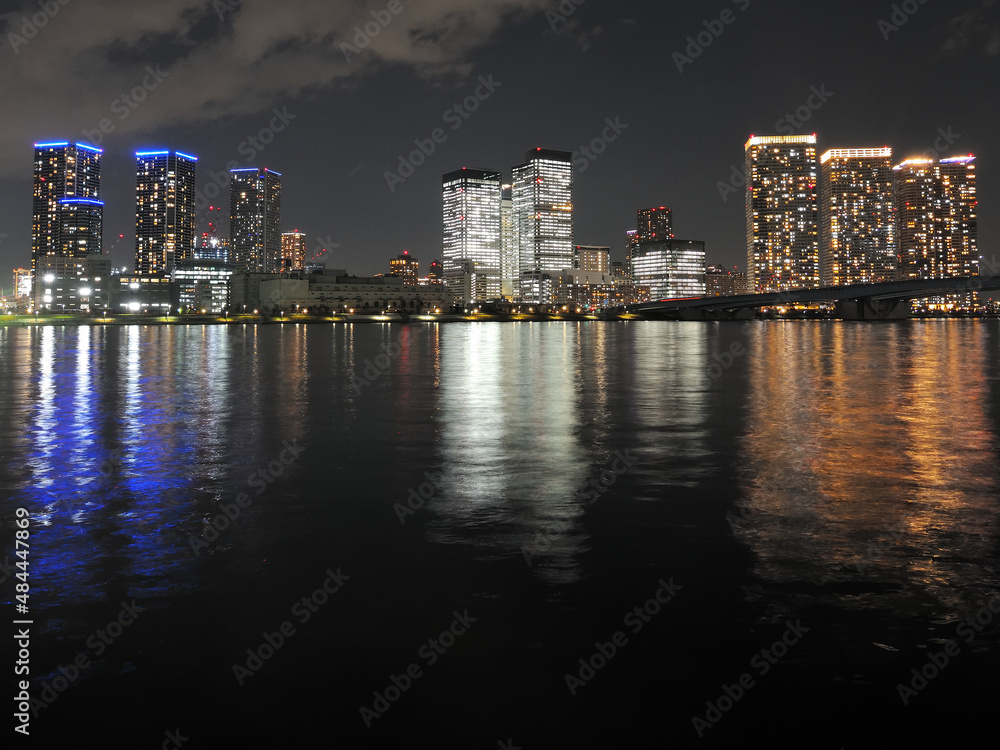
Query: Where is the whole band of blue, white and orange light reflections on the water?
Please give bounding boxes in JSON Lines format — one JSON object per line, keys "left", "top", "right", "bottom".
{"left": 0, "top": 321, "right": 1000, "bottom": 644}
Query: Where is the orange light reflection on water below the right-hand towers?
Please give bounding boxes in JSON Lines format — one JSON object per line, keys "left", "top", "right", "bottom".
{"left": 738, "top": 321, "right": 1000, "bottom": 620}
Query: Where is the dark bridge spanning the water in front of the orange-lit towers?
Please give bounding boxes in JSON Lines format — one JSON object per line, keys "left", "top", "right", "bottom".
{"left": 626, "top": 276, "right": 1000, "bottom": 320}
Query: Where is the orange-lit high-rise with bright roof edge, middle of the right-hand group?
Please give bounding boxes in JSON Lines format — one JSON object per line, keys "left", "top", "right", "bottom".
{"left": 820, "top": 147, "right": 897, "bottom": 286}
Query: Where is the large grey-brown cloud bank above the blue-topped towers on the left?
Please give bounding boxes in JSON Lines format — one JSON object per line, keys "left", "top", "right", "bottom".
{"left": 0, "top": 0, "right": 546, "bottom": 174}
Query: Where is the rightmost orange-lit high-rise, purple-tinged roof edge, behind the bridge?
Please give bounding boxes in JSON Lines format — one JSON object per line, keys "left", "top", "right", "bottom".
{"left": 894, "top": 155, "right": 979, "bottom": 309}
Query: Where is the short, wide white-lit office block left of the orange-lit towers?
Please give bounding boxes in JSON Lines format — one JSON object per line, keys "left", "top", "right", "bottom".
{"left": 632, "top": 239, "right": 705, "bottom": 300}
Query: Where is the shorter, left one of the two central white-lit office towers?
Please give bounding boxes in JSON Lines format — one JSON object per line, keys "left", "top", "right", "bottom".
{"left": 442, "top": 169, "right": 503, "bottom": 304}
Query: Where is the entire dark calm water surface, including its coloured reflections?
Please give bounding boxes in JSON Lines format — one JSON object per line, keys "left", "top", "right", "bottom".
{"left": 0, "top": 321, "right": 1000, "bottom": 750}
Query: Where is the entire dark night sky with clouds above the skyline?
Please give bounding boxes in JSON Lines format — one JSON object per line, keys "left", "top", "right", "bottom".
{"left": 0, "top": 0, "right": 1000, "bottom": 284}
